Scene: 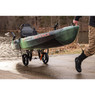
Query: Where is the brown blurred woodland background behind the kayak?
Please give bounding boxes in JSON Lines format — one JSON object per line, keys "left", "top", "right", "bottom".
{"left": 0, "top": 16, "right": 89, "bottom": 43}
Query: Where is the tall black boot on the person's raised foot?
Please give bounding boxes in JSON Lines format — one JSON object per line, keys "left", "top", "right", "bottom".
{"left": 75, "top": 51, "right": 87, "bottom": 72}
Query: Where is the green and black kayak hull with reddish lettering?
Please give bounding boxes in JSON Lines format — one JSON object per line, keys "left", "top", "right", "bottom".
{"left": 11, "top": 26, "right": 79, "bottom": 50}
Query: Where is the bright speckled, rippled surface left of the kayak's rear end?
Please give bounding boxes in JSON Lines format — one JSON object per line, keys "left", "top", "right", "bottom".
{"left": 0, "top": 37, "right": 20, "bottom": 58}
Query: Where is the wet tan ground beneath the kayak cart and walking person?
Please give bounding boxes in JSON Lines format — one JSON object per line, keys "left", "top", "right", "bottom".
{"left": 0, "top": 54, "right": 95, "bottom": 79}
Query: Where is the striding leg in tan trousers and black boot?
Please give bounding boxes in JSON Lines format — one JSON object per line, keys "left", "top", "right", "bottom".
{"left": 75, "top": 26, "right": 95, "bottom": 72}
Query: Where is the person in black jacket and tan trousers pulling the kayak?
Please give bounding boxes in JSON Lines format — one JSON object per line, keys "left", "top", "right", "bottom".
{"left": 73, "top": 16, "right": 95, "bottom": 72}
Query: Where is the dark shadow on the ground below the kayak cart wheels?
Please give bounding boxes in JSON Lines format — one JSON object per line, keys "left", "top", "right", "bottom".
{"left": 16, "top": 63, "right": 56, "bottom": 79}
